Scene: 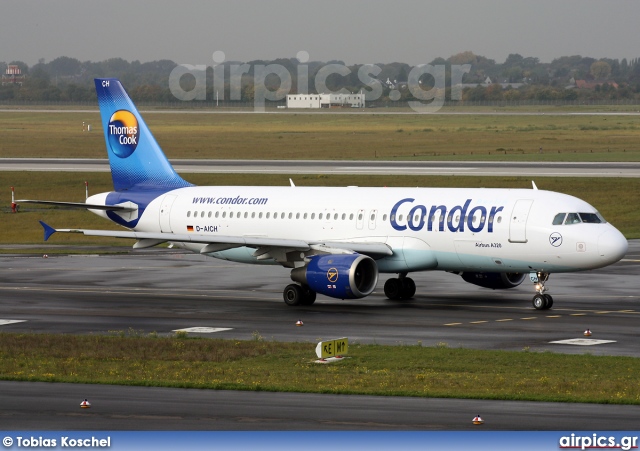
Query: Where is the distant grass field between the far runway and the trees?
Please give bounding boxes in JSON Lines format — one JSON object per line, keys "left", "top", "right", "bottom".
{"left": 0, "top": 110, "right": 640, "bottom": 161}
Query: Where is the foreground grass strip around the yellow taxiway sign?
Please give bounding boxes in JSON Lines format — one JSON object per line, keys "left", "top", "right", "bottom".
{"left": 0, "top": 331, "right": 640, "bottom": 404}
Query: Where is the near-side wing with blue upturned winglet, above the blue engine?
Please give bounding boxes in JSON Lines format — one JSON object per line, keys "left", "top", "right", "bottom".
{"left": 40, "top": 221, "right": 393, "bottom": 260}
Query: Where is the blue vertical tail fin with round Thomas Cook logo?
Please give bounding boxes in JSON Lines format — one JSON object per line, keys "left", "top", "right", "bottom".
{"left": 95, "top": 78, "right": 192, "bottom": 192}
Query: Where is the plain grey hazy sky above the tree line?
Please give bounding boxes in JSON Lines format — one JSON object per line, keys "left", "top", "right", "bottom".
{"left": 0, "top": 0, "right": 640, "bottom": 65}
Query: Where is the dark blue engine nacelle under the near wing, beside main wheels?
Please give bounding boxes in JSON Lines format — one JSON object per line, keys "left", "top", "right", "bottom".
{"left": 291, "top": 254, "right": 378, "bottom": 299}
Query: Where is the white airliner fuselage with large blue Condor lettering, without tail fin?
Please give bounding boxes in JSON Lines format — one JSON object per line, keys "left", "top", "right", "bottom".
{"left": 88, "top": 186, "right": 627, "bottom": 273}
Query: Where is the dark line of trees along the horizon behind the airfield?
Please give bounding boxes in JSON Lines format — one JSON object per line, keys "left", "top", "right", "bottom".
{"left": 0, "top": 52, "right": 640, "bottom": 103}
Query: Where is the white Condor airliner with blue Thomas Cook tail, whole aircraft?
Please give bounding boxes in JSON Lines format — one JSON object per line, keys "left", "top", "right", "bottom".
{"left": 19, "top": 79, "right": 628, "bottom": 310}
